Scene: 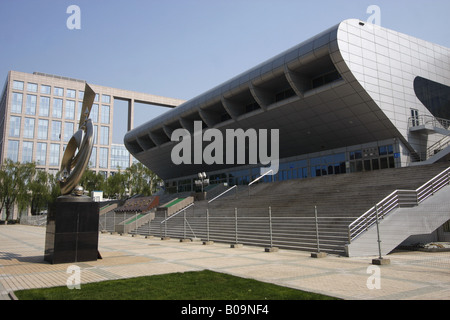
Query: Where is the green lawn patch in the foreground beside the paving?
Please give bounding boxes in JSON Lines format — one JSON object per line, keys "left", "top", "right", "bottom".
{"left": 15, "top": 270, "right": 335, "bottom": 300}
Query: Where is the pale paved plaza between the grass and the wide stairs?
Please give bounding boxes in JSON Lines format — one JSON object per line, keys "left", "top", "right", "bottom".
{"left": 0, "top": 225, "right": 450, "bottom": 300}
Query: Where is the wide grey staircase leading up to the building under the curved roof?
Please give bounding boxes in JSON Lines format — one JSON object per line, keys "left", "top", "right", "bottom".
{"left": 128, "top": 164, "right": 447, "bottom": 255}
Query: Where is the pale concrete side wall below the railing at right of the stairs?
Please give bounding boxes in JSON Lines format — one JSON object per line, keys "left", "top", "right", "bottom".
{"left": 347, "top": 186, "right": 450, "bottom": 257}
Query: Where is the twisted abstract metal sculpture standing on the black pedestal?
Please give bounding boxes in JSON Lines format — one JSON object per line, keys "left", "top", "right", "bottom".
{"left": 59, "top": 83, "right": 95, "bottom": 196}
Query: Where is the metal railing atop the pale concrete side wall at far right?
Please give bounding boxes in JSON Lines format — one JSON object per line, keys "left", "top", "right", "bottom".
{"left": 348, "top": 167, "right": 450, "bottom": 244}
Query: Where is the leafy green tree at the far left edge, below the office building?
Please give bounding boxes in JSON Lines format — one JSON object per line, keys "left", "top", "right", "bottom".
{"left": 0, "top": 160, "right": 36, "bottom": 220}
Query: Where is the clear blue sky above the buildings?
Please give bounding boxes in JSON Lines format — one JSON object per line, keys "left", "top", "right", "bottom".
{"left": 0, "top": 0, "right": 450, "bottom": 140}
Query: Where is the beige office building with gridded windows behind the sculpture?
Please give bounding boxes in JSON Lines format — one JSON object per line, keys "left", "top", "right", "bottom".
{"left": 0, "top": 71, "right": 184, "bottom": 176}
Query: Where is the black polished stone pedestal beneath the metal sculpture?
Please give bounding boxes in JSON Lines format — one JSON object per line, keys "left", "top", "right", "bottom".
{"left": 44, "top": 196, "right": 99, "bottom": 264}
